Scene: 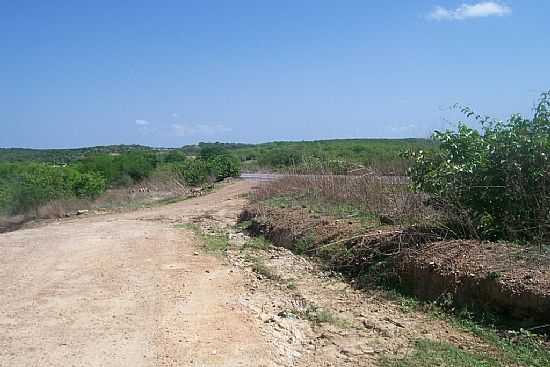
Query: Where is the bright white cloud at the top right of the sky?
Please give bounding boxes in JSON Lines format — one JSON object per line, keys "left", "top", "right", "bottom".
{"left": 428, "top": 1, "right": 512, "bottom": 20}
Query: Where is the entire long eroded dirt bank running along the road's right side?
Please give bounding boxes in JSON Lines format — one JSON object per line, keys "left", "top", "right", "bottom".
{"left": 241, "top": 207, "right": 550, "bottom": 325}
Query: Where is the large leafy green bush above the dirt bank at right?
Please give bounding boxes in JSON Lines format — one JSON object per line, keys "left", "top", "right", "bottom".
{"left": 409, "top": 93, "right": 550, "bottom": 241}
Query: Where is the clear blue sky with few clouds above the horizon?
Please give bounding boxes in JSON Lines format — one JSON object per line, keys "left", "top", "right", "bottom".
{"left": 0, "top": 0, "right": 550, "bottom": 148}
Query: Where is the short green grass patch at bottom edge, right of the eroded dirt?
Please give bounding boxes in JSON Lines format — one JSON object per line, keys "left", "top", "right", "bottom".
{"left": 382, "top": 339, "right": 501, "bottom": 367}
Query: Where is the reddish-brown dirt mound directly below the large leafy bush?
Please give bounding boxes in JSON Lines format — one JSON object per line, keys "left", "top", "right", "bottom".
{"left": 399, "top": 241, "right": 550, "bottom": 324}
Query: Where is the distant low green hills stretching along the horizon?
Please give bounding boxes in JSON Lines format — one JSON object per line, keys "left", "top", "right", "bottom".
{"left": 0, "top": 138, "right": 435, "bottom": 168}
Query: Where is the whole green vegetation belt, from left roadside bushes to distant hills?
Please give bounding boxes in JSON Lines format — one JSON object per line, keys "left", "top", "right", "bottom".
{"left": 0, "top": 139, "right": 433, "bottom": 214}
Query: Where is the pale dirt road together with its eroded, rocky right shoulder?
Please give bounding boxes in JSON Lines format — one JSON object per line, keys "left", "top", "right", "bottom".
{"left": 0, "top": 181, "right": 490, "bottom": 367}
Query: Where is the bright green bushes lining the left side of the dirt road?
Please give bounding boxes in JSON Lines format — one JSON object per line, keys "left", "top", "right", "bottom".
{"left": 0, "top": 149, "right": 240, "bottom": 215}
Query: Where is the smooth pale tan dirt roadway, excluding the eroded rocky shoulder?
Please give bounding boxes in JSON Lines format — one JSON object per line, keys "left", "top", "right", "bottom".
{"left": 0, "top": 182, "right": 280, "bottom": 367}
